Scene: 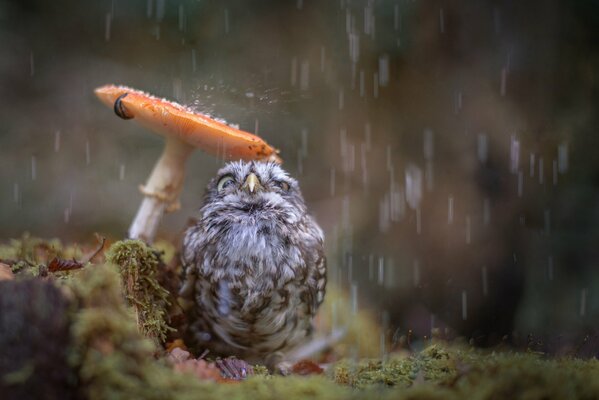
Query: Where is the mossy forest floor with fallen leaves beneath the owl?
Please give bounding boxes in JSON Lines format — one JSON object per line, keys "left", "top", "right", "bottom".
{"left": 0, "top": 235, "right": 599, "bottom": 400}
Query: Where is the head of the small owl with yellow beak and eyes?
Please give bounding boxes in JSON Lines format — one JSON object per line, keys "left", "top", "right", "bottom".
{"left": 202, "top": 161, "right": 306, "bottom": 222}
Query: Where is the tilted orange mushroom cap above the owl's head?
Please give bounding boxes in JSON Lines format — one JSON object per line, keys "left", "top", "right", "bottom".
{"left": 94, "top": 85, "right": 282, "bottom": 163}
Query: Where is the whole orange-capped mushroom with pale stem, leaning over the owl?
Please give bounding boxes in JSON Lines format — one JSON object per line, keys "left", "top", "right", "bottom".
{"left": 95, "top": 85, "right": 281, "bottom": 243}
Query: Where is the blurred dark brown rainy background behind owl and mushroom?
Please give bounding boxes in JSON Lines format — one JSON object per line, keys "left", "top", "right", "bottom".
{"left": 0, "top": 0, "right": 599, "bottom": 355}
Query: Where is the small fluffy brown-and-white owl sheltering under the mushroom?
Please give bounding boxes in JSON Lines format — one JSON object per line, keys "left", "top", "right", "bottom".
{"left": 181, "top": 162, "right": 326, "bottom": 362}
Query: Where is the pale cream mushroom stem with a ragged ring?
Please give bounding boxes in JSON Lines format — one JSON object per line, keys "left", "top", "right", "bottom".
{"left": 129, "top": 138, "right": 193, "bottom": 243}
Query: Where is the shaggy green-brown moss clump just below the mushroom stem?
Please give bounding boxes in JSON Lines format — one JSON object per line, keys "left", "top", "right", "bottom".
{"left": 106, "top": 240, "right": 171, "bottom": 342}
